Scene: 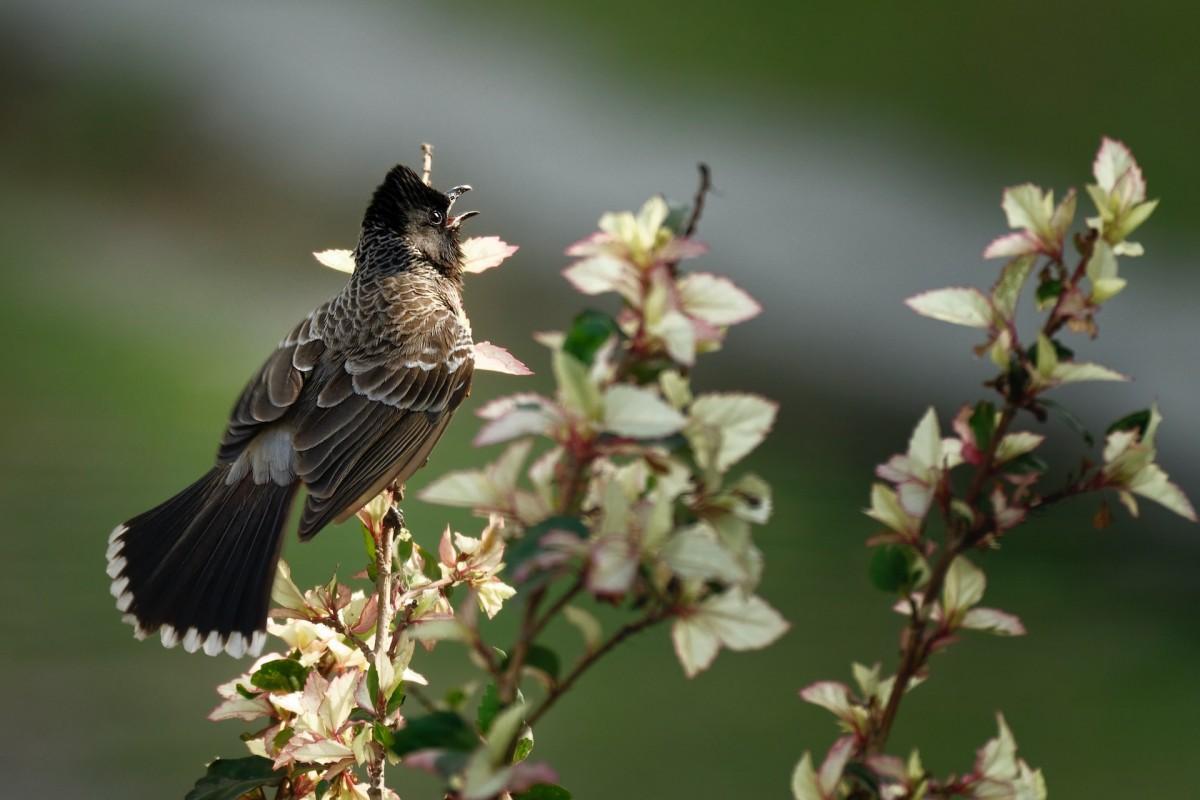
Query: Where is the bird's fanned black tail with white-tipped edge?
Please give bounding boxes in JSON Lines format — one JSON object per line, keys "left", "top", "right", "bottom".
{"left": 107, "top": 467, "right": 296, "bottom": 656}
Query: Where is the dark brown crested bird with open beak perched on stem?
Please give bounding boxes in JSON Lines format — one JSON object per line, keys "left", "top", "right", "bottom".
{"left": 106, "top": 164, "right": 478, "bottom": 657}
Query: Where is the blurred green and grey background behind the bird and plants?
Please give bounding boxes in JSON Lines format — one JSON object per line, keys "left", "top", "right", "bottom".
{"left": 0, "top": 0, "right": 1200, "bottom": 800}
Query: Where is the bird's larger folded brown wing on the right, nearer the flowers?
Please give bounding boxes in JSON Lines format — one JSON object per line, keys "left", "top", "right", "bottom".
{"left": 293, "top": 303, "right": 474, "bottom": 539}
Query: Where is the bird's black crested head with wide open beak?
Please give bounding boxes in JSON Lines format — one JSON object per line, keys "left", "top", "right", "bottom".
{"left": 356, "top": 166, "right": 479, "bottom": 281}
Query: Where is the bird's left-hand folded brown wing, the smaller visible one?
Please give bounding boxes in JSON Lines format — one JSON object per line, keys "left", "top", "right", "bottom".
{"left": 217, "top": 303, "right": 328, "bottom": 463}
